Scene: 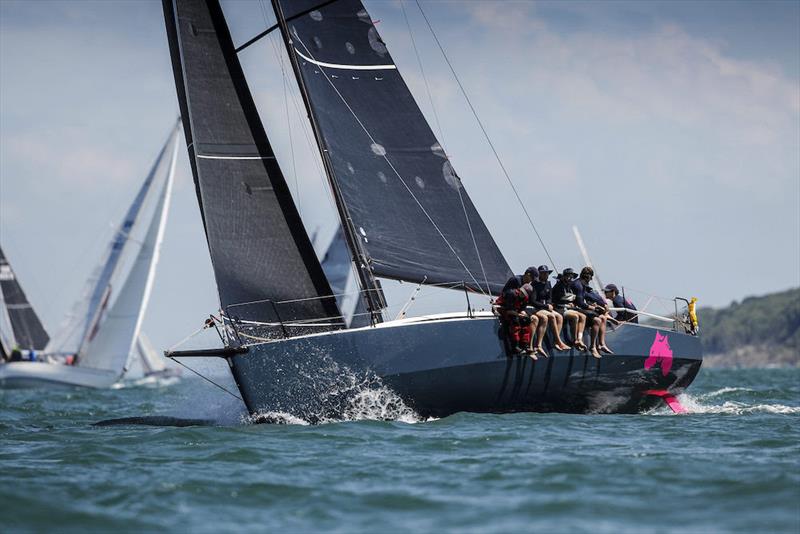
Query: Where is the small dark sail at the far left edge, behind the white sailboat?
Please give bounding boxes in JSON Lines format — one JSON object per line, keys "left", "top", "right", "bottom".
{"left": 0, "top": 248, "right": 50, "bottom": 350}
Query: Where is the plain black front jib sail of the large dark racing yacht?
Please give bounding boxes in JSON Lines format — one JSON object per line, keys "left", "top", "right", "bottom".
{"left": 163, "top": 0, "right": 340, "bottom": 323}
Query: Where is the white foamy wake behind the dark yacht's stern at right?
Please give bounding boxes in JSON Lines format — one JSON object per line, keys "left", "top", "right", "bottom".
{"left": 647, "top": 387, "right": 800, "bottom": 415}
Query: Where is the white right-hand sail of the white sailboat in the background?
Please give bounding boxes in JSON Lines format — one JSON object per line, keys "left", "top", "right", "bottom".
{"left": 78, "top": 136, "right": 177, "bottom": 375}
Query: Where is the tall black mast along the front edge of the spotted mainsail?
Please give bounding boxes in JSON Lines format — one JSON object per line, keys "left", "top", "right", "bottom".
{"left": 271, "top": 0, "right": 386, "bottom": 324}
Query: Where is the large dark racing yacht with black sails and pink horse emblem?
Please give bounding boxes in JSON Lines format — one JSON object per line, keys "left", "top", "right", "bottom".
{"left": 163, "top": 0, "right": 702, "bottom": 420}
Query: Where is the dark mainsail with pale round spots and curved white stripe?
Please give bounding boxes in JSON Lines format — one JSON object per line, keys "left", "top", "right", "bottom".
{"left": 273, "top": 0, "right": 511, "bottom": 293}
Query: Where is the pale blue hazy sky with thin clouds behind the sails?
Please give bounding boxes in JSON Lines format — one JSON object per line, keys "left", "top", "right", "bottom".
{"left": 0, "top": 0, "right": 800, "bottom": 360}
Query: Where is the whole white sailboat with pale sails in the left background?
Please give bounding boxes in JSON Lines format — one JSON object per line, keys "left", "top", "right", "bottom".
{"left": 0, "top": 123, "right": 180, "bottom": 388}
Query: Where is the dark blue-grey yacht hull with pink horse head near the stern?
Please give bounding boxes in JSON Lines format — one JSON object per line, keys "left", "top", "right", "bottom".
{"left": 219, "top": 317, "right": 702, "bottom": 420}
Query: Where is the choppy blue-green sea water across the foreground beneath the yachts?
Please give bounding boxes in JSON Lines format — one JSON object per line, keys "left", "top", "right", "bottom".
{"left": 0, "top": 369, "right": 800, "bottom": 533}
